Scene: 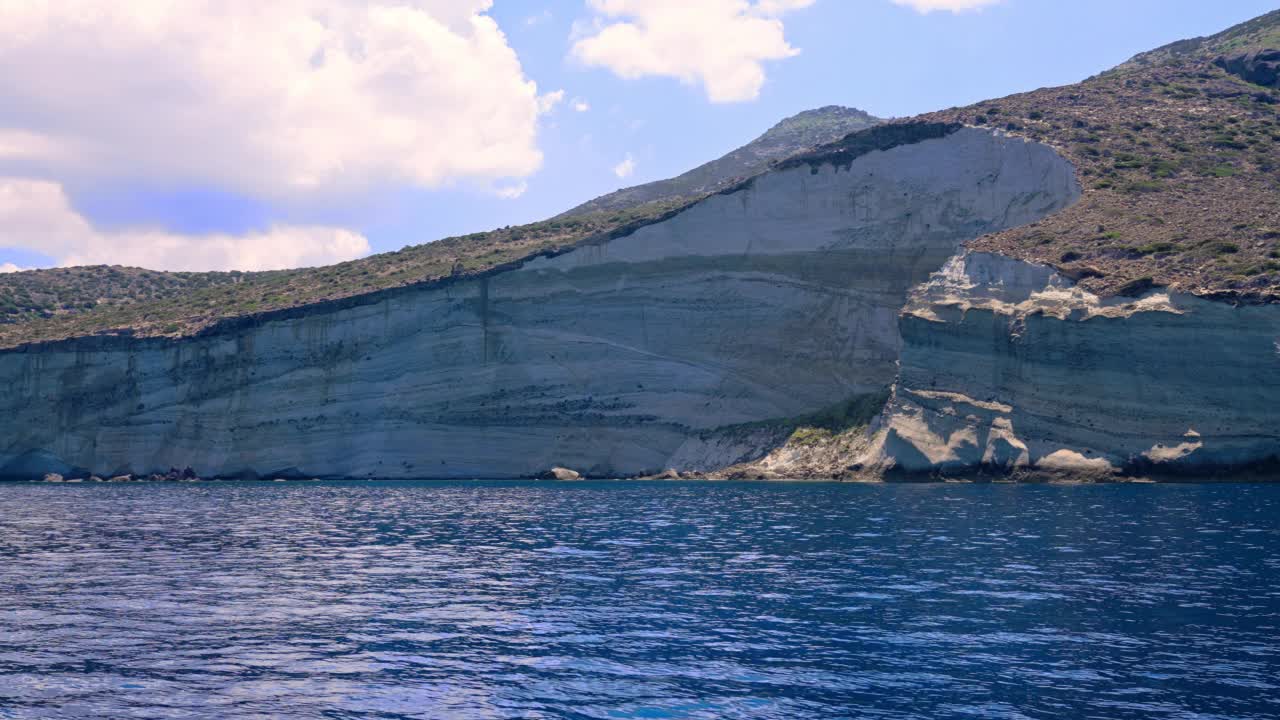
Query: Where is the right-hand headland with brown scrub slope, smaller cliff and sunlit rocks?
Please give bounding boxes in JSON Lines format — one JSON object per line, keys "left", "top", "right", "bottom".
{"left": 718, "top": 12, "right": 1280, "bottom": 479}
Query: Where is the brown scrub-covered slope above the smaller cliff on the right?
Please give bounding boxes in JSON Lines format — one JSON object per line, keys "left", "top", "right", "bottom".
{"left": 918, "top": 12, "right": 1280, "bottom": 302}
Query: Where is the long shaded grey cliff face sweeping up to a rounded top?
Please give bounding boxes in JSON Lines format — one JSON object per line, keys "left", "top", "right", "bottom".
{"left": 0, "top": 128, "right": 1079, "bottom": 478}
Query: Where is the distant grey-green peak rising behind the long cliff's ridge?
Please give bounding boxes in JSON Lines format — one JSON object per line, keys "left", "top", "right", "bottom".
{"left": 559, "top": 105, "right": 882, "bottom": 218}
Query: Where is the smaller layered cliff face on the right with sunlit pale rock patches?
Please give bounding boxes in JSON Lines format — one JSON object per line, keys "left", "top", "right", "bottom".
{"left": 868, "top": 254, "right": 1280, "bottom": 478}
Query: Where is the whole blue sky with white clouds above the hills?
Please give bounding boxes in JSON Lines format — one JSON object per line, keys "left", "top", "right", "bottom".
{"left": 0, "top": 0, "right": 1276, "bottom": 272}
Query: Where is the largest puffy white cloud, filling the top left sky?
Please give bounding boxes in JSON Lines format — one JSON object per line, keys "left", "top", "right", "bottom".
{"left": 0, "top": 0, "right": 545, "bottom": 197}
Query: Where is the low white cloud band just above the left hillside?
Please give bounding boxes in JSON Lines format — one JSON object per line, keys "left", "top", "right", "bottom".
{"left": 0, "top": 178, "right": 370, "bottom": 270}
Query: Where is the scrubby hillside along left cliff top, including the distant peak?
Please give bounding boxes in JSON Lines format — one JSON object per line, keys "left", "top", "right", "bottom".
{"left": 0, "top": 105, "right": 879, "bottom": 347}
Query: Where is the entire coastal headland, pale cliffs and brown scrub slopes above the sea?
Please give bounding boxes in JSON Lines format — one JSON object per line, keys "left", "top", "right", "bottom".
{"left": 0, "top": 12, "right": 1280, "bottom": 479}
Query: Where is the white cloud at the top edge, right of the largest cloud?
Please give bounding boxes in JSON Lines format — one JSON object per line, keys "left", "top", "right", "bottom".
{"left": 572, "top": 0, "right": 814, "bottom": 102}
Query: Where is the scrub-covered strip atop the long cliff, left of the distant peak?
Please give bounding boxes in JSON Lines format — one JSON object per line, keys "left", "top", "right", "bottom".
{"left": 0, "top": 197, "right": 699, "bottom": 347}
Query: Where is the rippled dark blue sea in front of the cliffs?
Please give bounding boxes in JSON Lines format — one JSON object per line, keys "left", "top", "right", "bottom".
{"left": 0, "top": 482, "right": 1280, "bottom": 720}
